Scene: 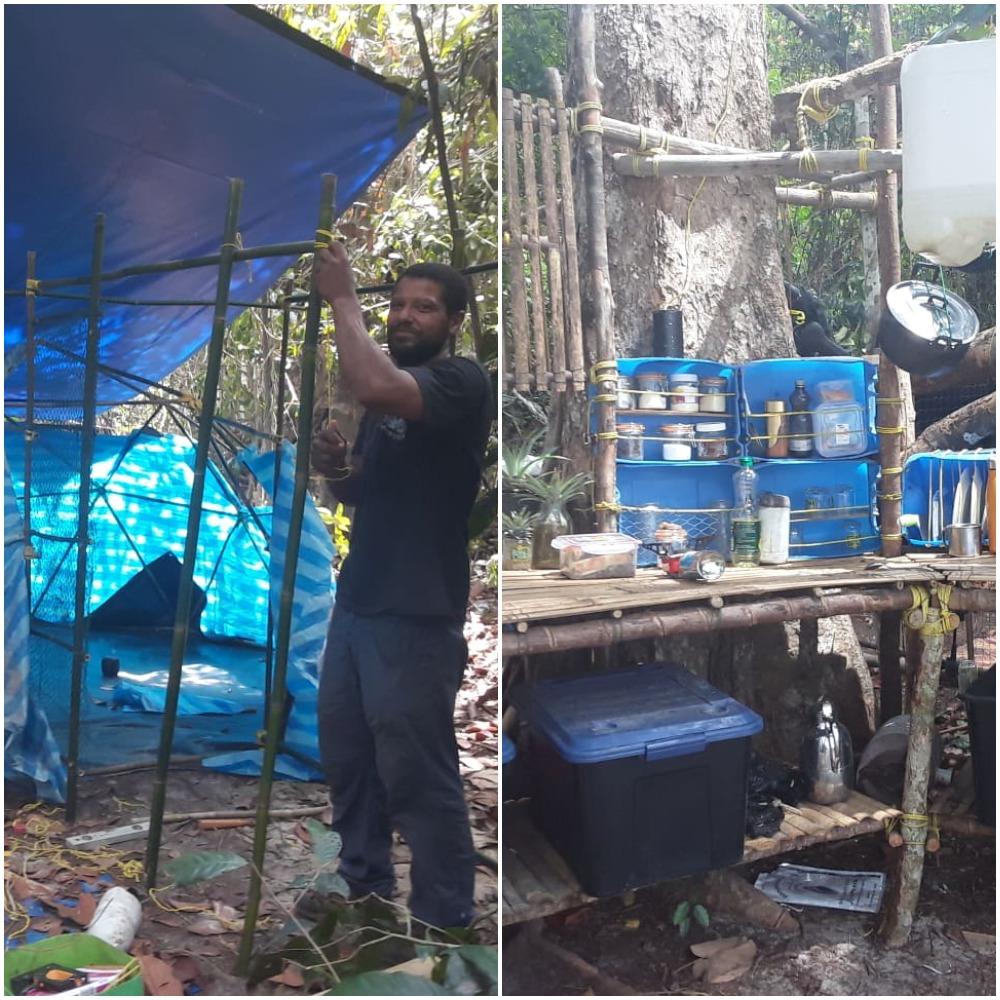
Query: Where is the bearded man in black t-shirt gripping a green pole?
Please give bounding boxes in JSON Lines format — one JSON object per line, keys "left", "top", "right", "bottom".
{"left": 312, "top": 243, "right": 494, "bottom": 927}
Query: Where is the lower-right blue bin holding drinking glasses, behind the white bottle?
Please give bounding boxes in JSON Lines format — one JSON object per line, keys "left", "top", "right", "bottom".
{"left": 754, "top": 459, "right": 881, "bottom": 560}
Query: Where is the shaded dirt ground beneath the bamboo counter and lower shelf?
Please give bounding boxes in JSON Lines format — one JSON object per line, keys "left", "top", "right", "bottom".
{"left": 502, "top": 812, "right": 996, "bottom": 996}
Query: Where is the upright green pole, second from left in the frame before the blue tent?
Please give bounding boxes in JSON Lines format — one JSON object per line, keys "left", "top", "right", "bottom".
{"left": 66, "top": 215, "right": 104, "bottom": 823}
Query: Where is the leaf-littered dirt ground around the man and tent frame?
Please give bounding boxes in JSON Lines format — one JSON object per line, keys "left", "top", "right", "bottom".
{"left": 5, "top": 594, "right": 499, "bottom": 996}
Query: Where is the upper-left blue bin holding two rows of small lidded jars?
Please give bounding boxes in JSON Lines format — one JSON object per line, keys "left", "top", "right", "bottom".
{"left": 591, "top": 358, "right": 743, "bottom": 464}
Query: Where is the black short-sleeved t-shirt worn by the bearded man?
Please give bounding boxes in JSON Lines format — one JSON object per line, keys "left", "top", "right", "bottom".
{"left": 337, "top": 358, "right": 493, "bottom": 619}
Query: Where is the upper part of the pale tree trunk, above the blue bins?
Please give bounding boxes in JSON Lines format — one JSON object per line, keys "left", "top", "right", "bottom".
{"left": 572, "top": 4, "right": 794, "bottom": 361}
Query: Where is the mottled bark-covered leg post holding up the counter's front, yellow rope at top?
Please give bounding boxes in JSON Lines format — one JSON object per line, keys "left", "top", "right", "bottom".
{"left": 879, "top": 601, "right": 945, "bottom": 948}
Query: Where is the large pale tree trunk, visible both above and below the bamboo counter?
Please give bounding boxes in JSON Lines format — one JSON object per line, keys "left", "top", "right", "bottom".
{"left": 557, "top": 4, "right": 874, "bottom": 759}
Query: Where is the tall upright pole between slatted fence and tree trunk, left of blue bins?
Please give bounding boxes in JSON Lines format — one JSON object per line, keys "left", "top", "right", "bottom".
{"left": 576, "top": 4, "right": 618, "bottom": 531}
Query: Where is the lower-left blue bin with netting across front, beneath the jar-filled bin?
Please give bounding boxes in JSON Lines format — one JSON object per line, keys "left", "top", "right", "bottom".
{"left": 615, "top": 461, "right": 737, "bottom": 566}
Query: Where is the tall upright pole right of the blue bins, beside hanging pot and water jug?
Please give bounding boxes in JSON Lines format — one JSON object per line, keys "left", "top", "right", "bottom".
{"left": 868, "top": 4, "right": 913, "bottom": 721}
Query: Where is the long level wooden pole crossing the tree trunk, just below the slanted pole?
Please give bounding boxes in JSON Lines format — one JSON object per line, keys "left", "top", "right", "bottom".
{"left": 611, "top": 149, "right": 903, "bottom": 177}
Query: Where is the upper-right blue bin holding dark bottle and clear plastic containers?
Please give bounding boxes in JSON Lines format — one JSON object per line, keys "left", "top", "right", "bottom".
{"left": 740, "top": 358, "right": 878, "bottom": 462}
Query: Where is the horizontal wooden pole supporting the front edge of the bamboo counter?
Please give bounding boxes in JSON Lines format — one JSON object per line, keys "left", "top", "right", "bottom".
{"left": 503, "top": 587, "right": 996, "bottom": 657}
